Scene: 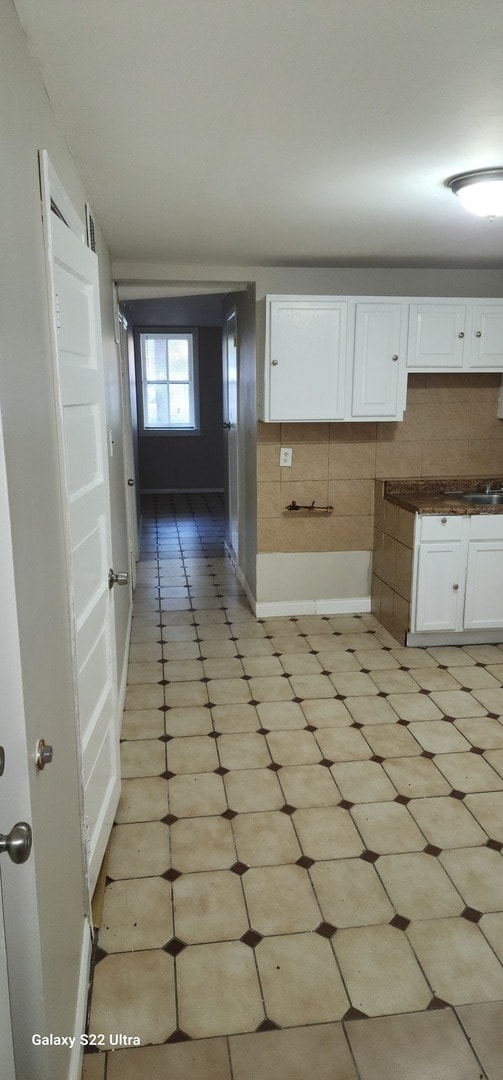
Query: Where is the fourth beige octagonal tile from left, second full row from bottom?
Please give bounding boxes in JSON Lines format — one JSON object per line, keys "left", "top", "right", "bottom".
{"left": 310, "top": 859, "right": 395, "bottom": 928}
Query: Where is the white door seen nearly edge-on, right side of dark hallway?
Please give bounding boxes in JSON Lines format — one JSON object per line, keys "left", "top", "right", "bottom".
{"left": 223, "top": 310, "right": 239, "bottom": 561}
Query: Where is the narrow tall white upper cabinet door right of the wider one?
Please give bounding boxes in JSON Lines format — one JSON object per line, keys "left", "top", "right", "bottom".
{"left": 351, "top": 303, "right": 407, "bottom": 420}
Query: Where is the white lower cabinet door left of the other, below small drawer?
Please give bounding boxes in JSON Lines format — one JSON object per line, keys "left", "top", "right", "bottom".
{"left": 413, "top": 540, "right": 463, "bottom": 631}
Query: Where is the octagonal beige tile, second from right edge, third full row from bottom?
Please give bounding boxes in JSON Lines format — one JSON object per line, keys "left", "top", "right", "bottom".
{"left": 408, "top": 796, "right": 487, "bottom": 848}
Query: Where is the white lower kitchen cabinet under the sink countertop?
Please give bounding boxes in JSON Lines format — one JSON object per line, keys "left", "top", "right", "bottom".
{"left": 407, "top": 514, "right": 503, "bottom": 645}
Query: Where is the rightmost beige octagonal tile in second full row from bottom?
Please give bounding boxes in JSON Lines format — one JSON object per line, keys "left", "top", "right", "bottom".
{"left": 438, "top": 848, "right": 503, "bottom": 912}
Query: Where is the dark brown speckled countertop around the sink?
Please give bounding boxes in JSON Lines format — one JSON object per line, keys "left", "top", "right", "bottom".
{"left": 384, "top": 476, "right": 503, "bottom": 515}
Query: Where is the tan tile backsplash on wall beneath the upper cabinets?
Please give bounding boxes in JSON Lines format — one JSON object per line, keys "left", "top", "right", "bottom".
{"left": 257, "top": 374, "right": 503, "bottom": 552}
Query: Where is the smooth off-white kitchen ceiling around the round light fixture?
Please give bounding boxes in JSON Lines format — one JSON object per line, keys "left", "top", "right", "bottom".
{"left": 15, "top": 0, "right": 503, "bottom": 267}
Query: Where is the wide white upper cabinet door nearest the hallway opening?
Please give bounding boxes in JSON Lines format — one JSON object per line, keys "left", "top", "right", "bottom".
{"left": 266, "top": 298, "right": 348, "bottom": 420}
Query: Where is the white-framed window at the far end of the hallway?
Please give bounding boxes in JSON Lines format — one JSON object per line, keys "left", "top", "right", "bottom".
{"left": 136, "top": 329, "right": 199, "bottom": 435}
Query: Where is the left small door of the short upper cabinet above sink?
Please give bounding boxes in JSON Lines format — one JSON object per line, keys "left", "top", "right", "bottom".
{"left": 407, "top": 303, "right": 467, "bottom": 372}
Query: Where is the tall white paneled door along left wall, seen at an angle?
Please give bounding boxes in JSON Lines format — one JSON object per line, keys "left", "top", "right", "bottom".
{"left": 44, "top": 203, "right": 120, "bottom": 893}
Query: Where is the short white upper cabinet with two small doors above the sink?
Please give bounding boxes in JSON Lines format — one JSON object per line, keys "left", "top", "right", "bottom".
{"left": 407, "top": 299, "right": 503, "bottom": 372}
